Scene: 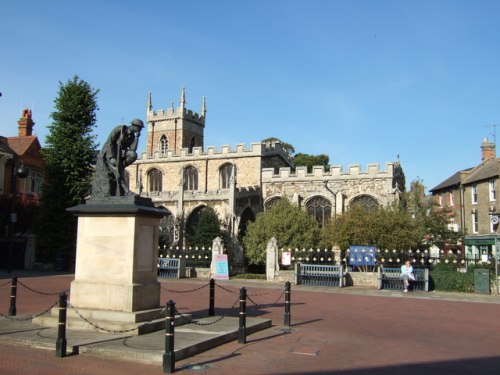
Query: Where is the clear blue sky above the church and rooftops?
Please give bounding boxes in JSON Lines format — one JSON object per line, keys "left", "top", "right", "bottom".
{"left": 0, "top": 0, "right": 500, "bottom": 194}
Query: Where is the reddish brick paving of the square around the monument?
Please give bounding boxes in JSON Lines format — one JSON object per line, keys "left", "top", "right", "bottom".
{"left": 0, "top": 275, "right": 500, "bottom": 375}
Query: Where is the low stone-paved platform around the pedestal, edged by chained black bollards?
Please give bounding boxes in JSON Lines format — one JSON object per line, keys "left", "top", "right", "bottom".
{"left": 0, "top": 316, "right": 272, "bottom": 364}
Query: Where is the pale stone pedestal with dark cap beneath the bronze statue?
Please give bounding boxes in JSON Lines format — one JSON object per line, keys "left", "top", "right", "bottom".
{"left": 35, "top": 197, "right": 172, "bottom": 334}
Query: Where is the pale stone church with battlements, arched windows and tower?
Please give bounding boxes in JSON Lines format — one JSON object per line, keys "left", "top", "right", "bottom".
{"left": 127, "top": 89, "right": 405, "bottom": 259}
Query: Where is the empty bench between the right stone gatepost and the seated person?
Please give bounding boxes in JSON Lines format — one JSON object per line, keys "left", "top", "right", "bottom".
{"left": 295, "top": 263, "right": 345, "bottom": 287}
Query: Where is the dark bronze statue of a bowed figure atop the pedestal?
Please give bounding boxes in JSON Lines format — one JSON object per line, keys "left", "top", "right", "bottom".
{"left": 92, "top": 119, "right": 144, "bottom": 198}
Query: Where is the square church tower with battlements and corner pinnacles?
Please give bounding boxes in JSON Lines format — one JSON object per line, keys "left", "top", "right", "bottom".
{"left": 146, "top": 88, "right": 207, "bottom": 156}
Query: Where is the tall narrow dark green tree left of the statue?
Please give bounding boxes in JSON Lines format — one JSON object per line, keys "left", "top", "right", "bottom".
{"left": 36, "top": 76, "right": 99, "bottom": 262}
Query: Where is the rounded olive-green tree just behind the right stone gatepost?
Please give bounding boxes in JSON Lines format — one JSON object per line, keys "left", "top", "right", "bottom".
{"left": 243, "top": 198, "right": 320, "bottom": 265}
